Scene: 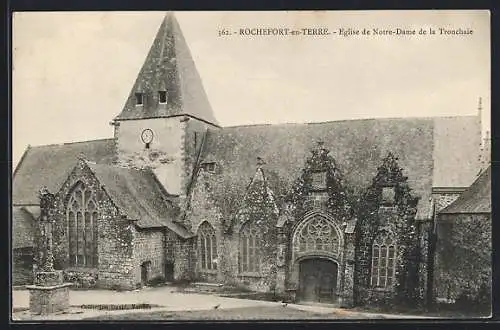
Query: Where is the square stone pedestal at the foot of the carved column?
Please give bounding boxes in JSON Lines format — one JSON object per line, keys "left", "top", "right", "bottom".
{"left": 26, "top": 271, "right": 73, "bottom": 315}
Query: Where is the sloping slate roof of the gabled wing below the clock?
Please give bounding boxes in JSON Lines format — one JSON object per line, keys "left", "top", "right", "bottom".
{"left": 87, "top": 163, "right": 192, "bottom": 238}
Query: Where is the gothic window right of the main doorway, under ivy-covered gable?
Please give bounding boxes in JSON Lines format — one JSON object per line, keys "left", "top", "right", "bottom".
{"left": 371, "top": 233, "right": 396, "bottom": 288}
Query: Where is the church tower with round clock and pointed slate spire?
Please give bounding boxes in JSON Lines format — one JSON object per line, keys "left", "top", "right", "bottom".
{"left": 111, "top": 13, "right": 219, "bottom": 198}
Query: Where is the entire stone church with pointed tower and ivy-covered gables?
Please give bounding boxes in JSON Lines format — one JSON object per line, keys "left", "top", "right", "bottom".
{"left": 12, "top": 14, "right": 488, "bottom": 305}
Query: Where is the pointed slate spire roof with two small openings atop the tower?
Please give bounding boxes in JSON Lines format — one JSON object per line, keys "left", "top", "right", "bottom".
{"left": 115, "top": 13, "right": 218, "bottom": 126}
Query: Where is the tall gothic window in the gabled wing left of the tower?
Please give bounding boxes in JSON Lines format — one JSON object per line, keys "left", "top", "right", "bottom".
{"left": 66, "top": 182, "right": 98, "bottom": 267}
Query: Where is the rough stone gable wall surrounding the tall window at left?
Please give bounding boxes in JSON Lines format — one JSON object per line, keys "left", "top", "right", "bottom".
{"left": 54, "top": 160, "right": 135, "bottom": 289}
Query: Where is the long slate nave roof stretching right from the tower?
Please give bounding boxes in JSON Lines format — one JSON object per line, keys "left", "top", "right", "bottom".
{"left": 201, "top": 116, "right": 479, "bottom": 219}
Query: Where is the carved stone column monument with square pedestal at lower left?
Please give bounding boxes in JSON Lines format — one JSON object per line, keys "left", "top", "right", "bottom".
{"left": 27, "top": 187, "right": 72, "bottom": 315}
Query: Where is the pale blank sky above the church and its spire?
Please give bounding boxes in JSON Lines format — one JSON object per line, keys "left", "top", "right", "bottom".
{"left": 12, "top": 11, "right": 490, "bottom": 167}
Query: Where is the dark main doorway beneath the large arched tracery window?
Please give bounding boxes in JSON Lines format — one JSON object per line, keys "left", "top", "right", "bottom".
{"left": 298, "top": 258, "right": 338, "bottom": 303}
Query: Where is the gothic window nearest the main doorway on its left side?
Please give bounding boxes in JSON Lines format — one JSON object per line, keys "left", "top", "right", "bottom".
{"left": 239, "top": 221, "right": 260, "bottom": 273}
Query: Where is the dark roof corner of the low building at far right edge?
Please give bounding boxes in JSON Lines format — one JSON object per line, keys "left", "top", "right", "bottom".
{"left": 439, "top": 166, "right": 491, "bottom": 214}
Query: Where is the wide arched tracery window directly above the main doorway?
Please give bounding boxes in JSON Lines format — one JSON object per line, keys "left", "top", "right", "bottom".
{"left": 297, "top": 216, "right": 340, "bottom": 252}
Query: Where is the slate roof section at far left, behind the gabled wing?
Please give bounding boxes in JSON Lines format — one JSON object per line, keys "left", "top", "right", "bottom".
{"left": 12, "top": 139, "right": 115, "bottom": 205}
